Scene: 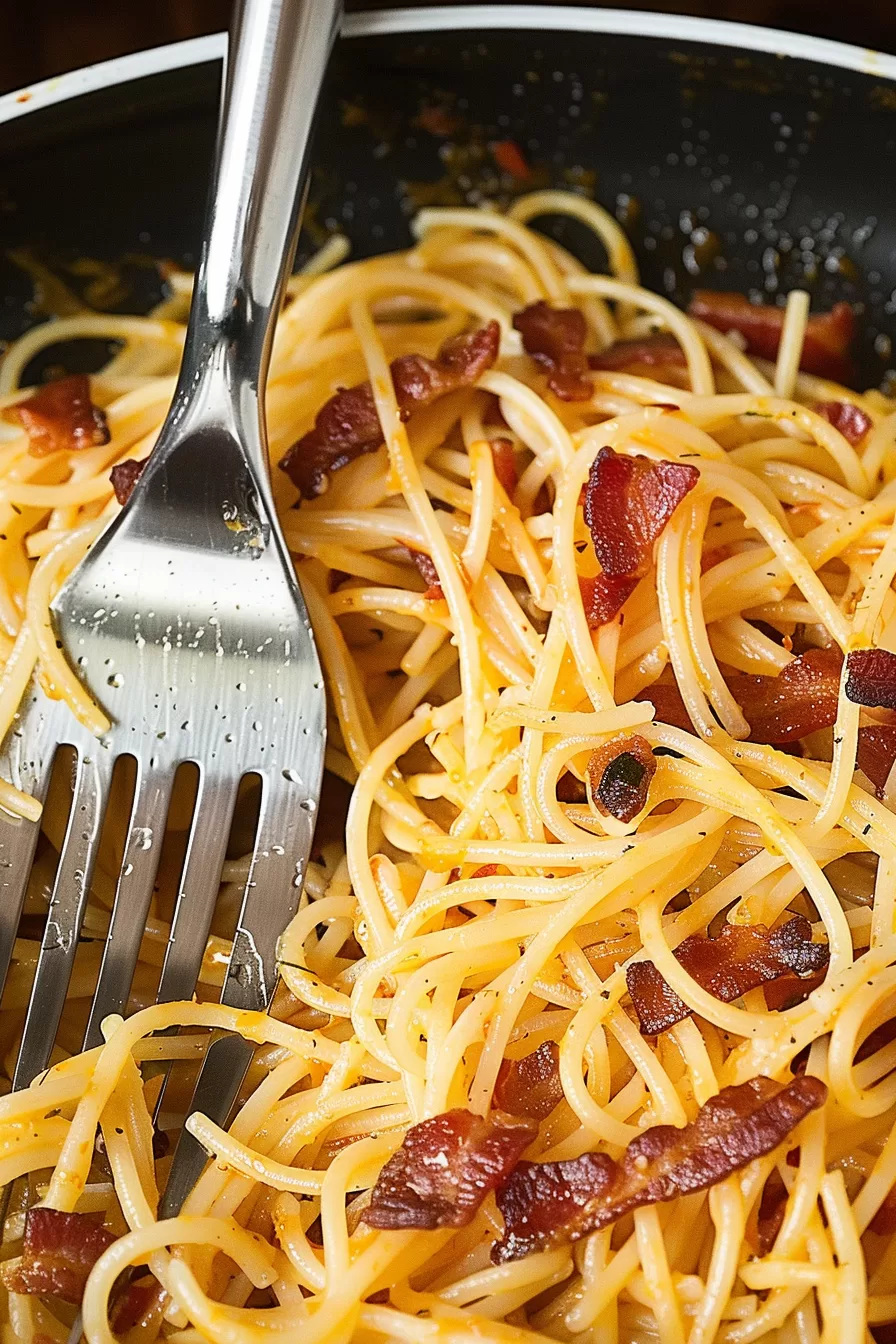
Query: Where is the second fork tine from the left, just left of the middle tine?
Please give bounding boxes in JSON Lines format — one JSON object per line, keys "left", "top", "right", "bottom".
{"left": 12, "top": 746, "right": 111, "bottom": 1091}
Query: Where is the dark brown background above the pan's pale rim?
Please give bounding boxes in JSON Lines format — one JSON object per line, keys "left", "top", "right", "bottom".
{"left": 0, "top": 0, "right": 896, "bottom": 90}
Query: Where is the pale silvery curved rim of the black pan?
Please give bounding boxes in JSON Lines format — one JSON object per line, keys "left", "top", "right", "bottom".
{"left": 0, "top": 4, "right": 896, "bottom": 124}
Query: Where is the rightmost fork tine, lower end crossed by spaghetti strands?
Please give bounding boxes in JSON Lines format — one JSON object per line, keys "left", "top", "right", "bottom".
{"left": 160, "top": 774, "right": 317, "bottom": 1218}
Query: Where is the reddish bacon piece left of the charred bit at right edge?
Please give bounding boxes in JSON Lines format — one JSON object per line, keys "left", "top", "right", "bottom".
{"left": 728, "top": 646, "right": 848, "bottom": 743}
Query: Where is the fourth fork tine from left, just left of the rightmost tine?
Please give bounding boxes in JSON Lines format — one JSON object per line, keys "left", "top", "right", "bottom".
{"left": 157, "top": 771, "right": 239, "bottom": 1003}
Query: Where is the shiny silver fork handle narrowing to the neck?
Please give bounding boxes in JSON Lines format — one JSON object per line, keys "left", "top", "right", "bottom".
{"left": 153, "top": 0, "right": 343, "bottom": 465}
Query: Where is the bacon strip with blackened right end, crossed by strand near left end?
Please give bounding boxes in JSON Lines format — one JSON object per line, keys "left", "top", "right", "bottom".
{"left": 626, "top": 915, "right": 830, "bottom": 1036}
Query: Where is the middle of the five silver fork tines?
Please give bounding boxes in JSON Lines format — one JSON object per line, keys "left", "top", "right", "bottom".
{"left": 83, "top": 762, "right": 173, "bottom": 1050}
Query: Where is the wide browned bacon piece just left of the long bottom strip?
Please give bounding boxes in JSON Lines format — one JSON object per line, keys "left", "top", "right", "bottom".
{"left": 361, "top": 1110, "right": 537, "bottom": 1228}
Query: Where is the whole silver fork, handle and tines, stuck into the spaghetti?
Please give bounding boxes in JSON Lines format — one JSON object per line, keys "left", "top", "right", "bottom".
{"left": 0, "top": 0, "right": 340, "bottom": 1216}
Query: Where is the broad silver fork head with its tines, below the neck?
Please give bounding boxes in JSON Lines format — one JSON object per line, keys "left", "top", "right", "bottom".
{"left": 0, "top": 396, "right": 325, "bottom": 1086}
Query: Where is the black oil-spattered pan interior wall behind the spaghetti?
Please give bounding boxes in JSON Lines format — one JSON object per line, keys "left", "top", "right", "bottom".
{"left": 0, "top": 16, "right": 896, "bottom": 384}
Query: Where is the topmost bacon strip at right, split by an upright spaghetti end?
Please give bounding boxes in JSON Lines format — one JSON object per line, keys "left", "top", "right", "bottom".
{"left": 688, "top": 289, "right": 856, "bottom": 383}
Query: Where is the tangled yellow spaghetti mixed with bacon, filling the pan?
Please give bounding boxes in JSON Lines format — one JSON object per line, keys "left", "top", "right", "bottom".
{"left": 0, "top": 192, "right": 896, "bottom": 1344}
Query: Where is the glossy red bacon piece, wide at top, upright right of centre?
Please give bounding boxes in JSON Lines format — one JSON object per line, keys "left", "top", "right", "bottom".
{"left": 584, "top": 448, "right": 700, "bottom": 578}
